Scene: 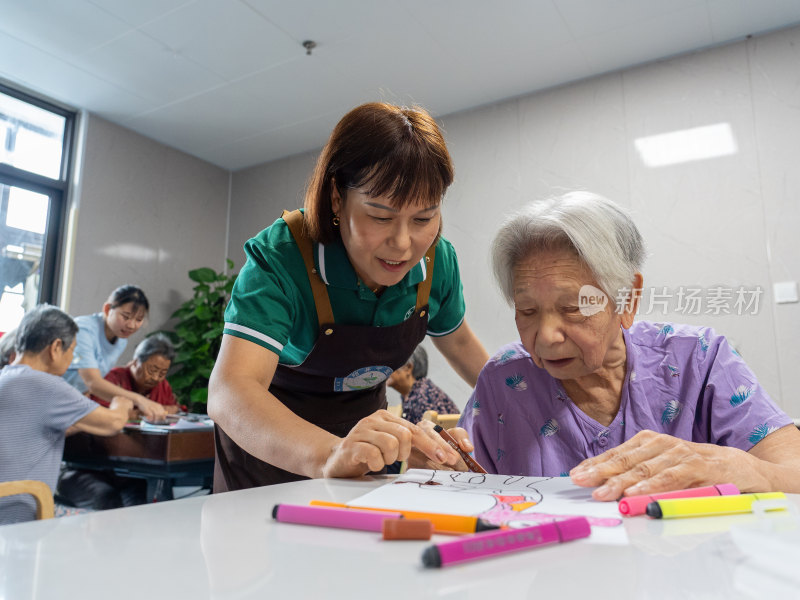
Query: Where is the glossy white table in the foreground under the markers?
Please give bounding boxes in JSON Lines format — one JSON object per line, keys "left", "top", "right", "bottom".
{"left": 0, "top": 477, "right": 800, "bottom": 600}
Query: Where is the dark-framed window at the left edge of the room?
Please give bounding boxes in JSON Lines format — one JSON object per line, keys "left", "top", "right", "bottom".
{"left": 0, "top": 84, "right": 75, "bottom": 334}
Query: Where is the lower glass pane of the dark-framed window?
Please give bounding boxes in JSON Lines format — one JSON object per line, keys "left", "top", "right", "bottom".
{"left": 0, "top": 184, "right": 50, "bottom": 332}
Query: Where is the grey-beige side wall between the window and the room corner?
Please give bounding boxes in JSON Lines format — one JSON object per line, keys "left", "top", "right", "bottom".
{"left": 66, "top": 116, "right": 229, "bottom": 356}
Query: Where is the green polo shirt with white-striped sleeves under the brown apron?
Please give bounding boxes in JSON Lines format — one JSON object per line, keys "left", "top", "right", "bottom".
{"left": 224, "top": 219, "right": 465, "bottom": 365}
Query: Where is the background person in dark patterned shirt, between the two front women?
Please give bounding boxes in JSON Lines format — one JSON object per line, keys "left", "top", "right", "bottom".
{"left": 386, "top": 346, "right": 461, "bottom": 423}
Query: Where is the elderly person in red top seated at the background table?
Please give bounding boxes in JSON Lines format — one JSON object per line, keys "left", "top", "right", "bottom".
{"left": 91, "top": 333, "right": 180, "bottom": 414}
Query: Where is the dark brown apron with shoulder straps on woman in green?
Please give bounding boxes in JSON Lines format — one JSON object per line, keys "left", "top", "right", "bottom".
{"left": 214, "top": 210, "right": 435, "bottom": 492}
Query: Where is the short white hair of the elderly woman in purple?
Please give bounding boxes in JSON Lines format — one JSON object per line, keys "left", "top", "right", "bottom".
{"left": 492, "top": 192, "right": 645, "bottom": 306}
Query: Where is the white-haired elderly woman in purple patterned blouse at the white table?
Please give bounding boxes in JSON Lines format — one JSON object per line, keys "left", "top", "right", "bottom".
{"left": 453, "top": 192, "right": 800, "bottom": 500}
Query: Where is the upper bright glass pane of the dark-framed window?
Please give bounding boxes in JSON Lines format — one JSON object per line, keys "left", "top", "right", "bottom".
{"left": 0, "top": 93, "right": 66, "bottom": 179}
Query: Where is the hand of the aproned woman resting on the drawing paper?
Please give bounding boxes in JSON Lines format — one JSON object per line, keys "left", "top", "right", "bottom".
{"left": 322, "top": 410, "right": 460, "bottom": 477}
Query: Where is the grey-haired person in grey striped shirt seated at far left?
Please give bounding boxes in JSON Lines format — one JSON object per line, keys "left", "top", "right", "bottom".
{"left": 0, "top": 304, "right": 133, "bottom": 524}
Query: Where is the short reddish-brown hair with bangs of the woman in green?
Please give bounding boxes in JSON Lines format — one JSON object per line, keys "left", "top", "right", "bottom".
{"left": 305, "top": 102, "right": 453, "bottom": 243}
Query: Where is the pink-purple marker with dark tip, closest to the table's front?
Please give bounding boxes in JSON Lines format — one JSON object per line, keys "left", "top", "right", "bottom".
{"left": 422, "top": 517, "right": 592, "bottom": 567}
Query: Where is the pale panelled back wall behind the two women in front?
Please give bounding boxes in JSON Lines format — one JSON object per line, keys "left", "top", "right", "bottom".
{"left": 229, "top": 23, "right": 800, "bottom": 416}
